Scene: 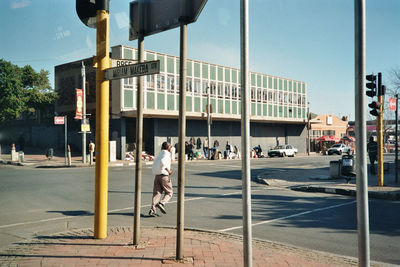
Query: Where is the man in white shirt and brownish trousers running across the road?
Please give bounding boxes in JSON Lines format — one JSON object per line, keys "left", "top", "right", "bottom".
{"left": 149, "top": 142, "right": 173, "bottom": 217}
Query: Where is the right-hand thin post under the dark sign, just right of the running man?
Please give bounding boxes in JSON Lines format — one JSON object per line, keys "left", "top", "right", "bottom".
{"left": 176, "top": 20, "right": 187, "bottom": 260}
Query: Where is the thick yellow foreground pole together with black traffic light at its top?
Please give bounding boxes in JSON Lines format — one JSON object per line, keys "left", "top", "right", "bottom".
{"left": 76, "top": 0, "right": 110, "bottom": 239}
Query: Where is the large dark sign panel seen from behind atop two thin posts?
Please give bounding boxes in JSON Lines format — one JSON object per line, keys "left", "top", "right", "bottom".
{"left": 129, "top": 0, "right": 207, "bottom": 41}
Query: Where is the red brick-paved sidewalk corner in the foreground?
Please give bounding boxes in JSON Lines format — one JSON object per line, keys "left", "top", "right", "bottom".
{"left": 0, "top": 227, "right": 376, "bottom": 267}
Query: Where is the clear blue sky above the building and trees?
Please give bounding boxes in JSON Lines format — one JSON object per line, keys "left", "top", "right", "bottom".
{"left": 0, "top": 0, "right": 400, "bottom": 119}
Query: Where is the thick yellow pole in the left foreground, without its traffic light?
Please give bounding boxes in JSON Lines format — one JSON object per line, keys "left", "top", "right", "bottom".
{"left": 94, "top": 10, "right": 110, "bottom": 239}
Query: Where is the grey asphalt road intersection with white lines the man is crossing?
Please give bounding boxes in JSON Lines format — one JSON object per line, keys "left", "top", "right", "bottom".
{"left": 0, "top": 156, "right": 400, "bottom": 264}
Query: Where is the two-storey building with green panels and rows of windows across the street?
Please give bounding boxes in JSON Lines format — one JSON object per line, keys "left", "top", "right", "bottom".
{"left": 55, "top": 45, "right": 307, "bottom": 159}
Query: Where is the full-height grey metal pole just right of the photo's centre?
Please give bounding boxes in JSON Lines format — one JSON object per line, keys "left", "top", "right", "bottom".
{"left": 240, "top": 0, "right": 253, "bottom": 267}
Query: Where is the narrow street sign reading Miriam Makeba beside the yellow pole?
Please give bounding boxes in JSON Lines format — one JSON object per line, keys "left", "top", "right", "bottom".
{"left": 105, "top": 60, "right": 160, "bottom": 80}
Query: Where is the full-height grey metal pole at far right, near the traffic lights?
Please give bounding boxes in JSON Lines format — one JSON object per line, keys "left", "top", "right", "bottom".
{"left": 354, "top": 0, "right": 370, "bottom": 266}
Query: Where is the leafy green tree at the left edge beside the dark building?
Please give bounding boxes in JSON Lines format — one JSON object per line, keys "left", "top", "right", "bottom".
{"left": 0, "top": 59, "right": 57, "bottom": 123}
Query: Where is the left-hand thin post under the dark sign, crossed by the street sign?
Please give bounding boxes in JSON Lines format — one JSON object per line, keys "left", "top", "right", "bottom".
{"left": 133, "top": 34, "right": 144, "bottom": 248}
